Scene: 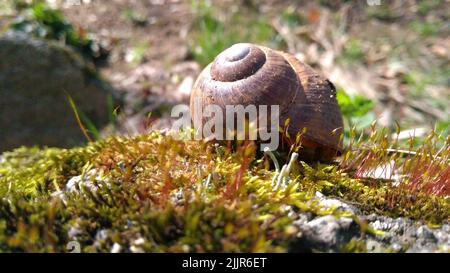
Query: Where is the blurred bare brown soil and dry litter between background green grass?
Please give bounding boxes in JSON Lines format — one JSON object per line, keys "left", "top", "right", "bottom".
{"left": 6, "top": 0, "right": 450, "bottom": 133}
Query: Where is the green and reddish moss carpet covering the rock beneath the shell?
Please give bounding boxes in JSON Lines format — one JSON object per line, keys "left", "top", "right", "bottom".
{"left": 0, "top": 127, "right": 450, "bottom": 252}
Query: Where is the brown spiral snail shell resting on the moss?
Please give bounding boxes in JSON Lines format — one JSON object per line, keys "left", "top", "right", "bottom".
{"left": 190, "top": 43, "right": 343, "bottom": 161}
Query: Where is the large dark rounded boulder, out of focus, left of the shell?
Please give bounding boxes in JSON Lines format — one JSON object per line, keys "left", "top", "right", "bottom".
{"left": 0, "top": 32, "right": 116, "bottom": 151}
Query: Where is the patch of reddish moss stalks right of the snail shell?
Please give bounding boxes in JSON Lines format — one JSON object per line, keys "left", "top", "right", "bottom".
{"left": 340, "top": 127, "right": 450, "bottom": 197}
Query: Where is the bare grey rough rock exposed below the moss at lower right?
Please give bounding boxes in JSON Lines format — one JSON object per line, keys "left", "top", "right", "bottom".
{"left": 289, "top": 193, "right": 450, "bottom": 252}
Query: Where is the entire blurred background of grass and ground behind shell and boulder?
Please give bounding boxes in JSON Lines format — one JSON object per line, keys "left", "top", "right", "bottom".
{"left": 0, "top": 0, "right": 450, "bottom": 144}
